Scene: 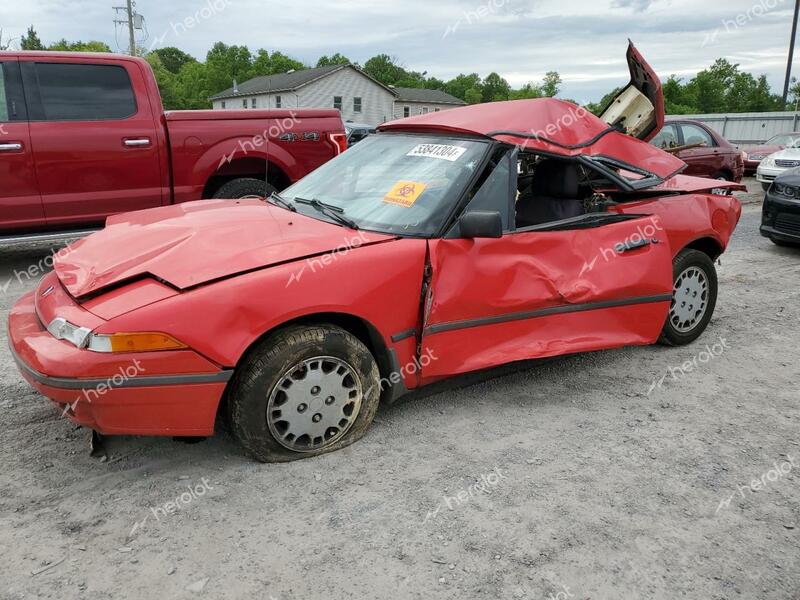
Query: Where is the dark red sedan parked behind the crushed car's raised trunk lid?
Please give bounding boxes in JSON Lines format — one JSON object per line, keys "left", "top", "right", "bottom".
{"left": 650, "top": 120, "right": 744, "bottom": 183}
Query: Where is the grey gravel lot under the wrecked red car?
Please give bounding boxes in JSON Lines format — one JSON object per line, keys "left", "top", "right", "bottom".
{"left": 0, "top": 179, "right": 800, "bottom": 600}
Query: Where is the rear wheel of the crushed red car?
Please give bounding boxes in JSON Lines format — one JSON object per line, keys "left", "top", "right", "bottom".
{"left": 658, "top": 248, "right": 719, "bottom": 346}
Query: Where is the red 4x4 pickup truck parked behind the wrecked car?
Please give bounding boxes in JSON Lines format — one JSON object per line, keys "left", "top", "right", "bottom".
{"left": 0, "top": 52, "right": 347, "bottom": 238}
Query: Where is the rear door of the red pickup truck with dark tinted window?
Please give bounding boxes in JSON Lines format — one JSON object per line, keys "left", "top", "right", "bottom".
{"left": 20, "top": 57, "right": 164, "bottom": 227}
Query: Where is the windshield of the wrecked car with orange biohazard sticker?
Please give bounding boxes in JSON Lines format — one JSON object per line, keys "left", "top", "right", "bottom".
{"left": 281, "top": 133, "right": 490, "bottom": 236}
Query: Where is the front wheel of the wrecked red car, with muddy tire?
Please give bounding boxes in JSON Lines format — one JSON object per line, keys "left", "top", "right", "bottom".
{"left": 228, "top": 325, "right": 381, "bottom": 462}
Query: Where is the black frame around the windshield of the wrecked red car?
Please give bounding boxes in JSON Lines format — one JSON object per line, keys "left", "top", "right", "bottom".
{"left": 281, "top": 130, "right": 499, "bottom": 239}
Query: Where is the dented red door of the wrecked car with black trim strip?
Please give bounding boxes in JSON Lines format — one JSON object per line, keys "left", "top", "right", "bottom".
{"left": 421, "top": 152, "right": 672, "bottom": 383}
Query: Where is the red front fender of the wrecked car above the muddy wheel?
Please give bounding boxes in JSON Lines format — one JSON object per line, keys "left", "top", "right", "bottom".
{"left": 97, "top": 239, "right": 426, "bottom": 387}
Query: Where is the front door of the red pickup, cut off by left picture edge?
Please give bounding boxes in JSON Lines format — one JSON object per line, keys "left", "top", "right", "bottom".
{"left": 0, "top": 58, "right": 45, "bottom": 232}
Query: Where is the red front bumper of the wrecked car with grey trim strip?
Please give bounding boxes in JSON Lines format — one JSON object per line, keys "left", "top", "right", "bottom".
{"left": 8, "top": 288, "right": 233, "bottom": 436}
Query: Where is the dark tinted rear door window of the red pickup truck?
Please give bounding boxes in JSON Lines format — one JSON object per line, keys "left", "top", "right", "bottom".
{"left": 36, "top": 63, "right": 136, "bottom": 121}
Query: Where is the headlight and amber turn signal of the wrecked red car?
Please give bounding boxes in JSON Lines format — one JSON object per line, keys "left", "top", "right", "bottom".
{"left": 47, "top": 317, "right": 188, "bottom": 353}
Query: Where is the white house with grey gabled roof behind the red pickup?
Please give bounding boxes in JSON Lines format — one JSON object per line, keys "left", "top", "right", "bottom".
{"left": 211, "top": 65, "right": 466, "bottom": 126}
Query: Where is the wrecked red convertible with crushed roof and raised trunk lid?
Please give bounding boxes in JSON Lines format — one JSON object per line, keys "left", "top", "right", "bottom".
{"left": 9, "top": 47, "right": 742, "bottom": 461}
